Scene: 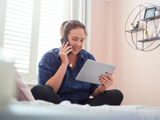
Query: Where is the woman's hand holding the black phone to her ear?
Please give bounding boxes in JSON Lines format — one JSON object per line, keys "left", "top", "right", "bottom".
{"left": 59, "top": 42, "right": 73, "bottom": 65}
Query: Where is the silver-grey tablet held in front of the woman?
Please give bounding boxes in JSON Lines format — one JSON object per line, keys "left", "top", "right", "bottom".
{"left": 76, "top": 59, "right": 116, "bottom": 84}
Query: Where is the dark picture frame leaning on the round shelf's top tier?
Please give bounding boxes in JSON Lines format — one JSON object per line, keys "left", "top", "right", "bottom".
{"left": 144, "top": 7, "right": 157, "bottom": 19}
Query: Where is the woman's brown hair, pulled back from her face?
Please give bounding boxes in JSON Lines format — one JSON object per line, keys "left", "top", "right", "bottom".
{"left": 60, "top": 20, "right": 87, "bottom": 37}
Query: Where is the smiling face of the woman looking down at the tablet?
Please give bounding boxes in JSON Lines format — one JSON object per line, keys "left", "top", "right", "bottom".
{"left": 68, "top": 27, "right": 86, "bottom": 55}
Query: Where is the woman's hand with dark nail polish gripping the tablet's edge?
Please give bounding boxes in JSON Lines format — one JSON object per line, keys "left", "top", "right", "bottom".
{"left": 98, "top": 73, "right": 114, "bottom": 92}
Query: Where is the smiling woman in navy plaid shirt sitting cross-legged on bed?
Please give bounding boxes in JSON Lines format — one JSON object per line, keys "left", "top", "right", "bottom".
{"left": 31, "top": 20, "right": 123, "bottom": 106}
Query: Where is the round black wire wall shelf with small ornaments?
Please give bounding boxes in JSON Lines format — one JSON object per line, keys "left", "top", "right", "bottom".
{"left": 125, "top": 3, "right": 160, "bottom": 52}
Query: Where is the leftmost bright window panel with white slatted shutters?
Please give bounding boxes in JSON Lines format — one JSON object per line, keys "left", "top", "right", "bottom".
{"left": 3, "top": 0, "right": 33, "bottom": 73}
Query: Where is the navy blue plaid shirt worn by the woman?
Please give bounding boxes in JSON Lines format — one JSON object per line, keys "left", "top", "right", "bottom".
{"left": 38, "top": 48, "right": 98, "bottom": 104}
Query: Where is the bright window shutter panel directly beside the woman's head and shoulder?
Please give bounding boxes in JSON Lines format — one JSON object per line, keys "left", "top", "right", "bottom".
{"left": 37, "top": 0, "right": 64, "bottom": 71}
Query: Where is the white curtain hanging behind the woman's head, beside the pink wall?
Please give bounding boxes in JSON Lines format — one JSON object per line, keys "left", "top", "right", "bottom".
{"left": 70, "top": 0, "right": 91, "bottom": 52}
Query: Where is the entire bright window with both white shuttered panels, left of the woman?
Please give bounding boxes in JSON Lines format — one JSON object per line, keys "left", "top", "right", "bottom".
{"left": 1, "top": 0, "right": 66, "bottom": 84}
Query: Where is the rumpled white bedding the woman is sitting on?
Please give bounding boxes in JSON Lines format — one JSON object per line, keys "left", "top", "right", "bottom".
{"left": 0, "top": 99, "right": 160, "bottom": 120}
